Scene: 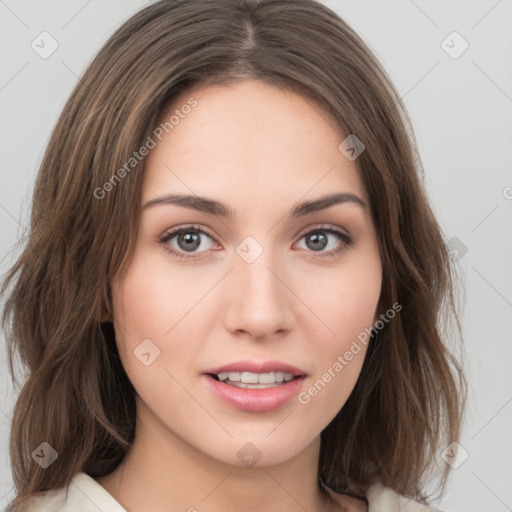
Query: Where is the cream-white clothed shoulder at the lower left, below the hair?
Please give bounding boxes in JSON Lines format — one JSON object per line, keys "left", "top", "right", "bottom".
{"left": 27, "top": 472, "right": 126, "bottom": 512}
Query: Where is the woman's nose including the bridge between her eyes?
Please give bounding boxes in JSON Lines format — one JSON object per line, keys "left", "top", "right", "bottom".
{"left": 226, "top": 237, "right": 291, "bottom": 338}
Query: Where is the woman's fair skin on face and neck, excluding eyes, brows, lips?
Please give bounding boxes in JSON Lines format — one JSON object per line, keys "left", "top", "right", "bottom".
{"left": 97, "top": 80, "right": 382, "bottom": 512}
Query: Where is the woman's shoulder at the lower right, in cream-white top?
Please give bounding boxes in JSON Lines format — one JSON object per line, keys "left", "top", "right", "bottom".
{"left": 322, "top": 484, "right": 440, "bottom": 512}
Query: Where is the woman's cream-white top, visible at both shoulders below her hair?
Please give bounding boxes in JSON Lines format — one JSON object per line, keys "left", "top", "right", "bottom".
{"left": 28, "top": 472, "right": 438, "bottom": 512}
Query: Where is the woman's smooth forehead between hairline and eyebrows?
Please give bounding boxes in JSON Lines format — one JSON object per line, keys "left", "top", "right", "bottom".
{"left": 142, "top": 80, "right": 366, "bottom": 204}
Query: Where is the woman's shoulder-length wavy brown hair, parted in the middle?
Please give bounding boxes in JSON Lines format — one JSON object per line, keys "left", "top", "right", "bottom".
{"left": 2, "top": 0, "right": 465, "bottom": 512}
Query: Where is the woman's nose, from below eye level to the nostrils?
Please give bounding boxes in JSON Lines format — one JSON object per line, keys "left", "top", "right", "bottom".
{"left": 224, "top": 247, "right": 296, "bottom": 341}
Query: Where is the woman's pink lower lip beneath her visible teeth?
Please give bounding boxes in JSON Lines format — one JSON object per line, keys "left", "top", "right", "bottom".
{"left": 203, "top": 375, "right": 306, "bottom": 412}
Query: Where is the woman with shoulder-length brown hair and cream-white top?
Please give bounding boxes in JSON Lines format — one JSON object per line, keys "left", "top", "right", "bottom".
{"left": 3, "top": 0, "right": 464, "bottom": 512}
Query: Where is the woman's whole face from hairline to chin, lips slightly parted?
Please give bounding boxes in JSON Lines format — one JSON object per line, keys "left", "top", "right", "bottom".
{"left": 112, "top": 81, "right": 381, "bottom": 466}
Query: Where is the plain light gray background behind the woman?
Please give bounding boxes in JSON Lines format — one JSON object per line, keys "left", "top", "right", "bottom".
{"left": 0, "top": 0, "right": 512, "bottom": 512}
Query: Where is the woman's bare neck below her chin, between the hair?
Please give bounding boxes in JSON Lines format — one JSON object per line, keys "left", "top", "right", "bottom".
{"left": 96, "top": 400, "right": 334, "bottom": 512}
